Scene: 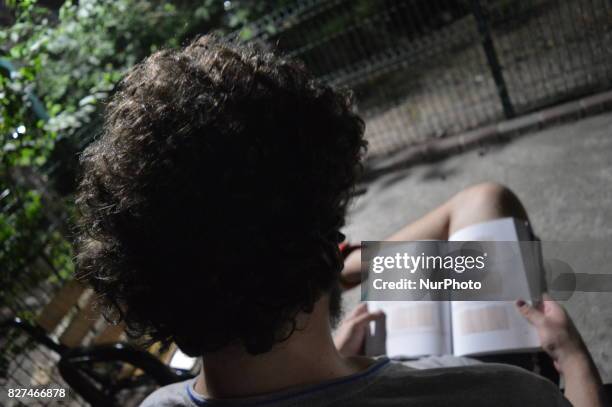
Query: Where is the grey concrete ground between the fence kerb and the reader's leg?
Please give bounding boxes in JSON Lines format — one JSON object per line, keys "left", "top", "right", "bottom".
{"left": 345, "top": 113, "right": 612, "bottom": 383}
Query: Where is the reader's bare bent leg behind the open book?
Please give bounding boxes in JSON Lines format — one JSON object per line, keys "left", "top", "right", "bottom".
{"left": 342, "top": 182, "right": 529, "bottom": 285}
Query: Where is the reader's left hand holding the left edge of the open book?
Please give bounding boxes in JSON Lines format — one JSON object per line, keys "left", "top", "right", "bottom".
{"left": 334, "top": 304, "right": 385, "bottom": 356}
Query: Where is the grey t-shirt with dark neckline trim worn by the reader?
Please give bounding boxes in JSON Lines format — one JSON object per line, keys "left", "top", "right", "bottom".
{"left": 141, "top": 358, "right": 571, "bottom": 407}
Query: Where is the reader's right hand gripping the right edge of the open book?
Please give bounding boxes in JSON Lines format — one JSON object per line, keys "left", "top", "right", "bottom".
{"left": 516, "top": 294, "right": 588, "bottom": 373}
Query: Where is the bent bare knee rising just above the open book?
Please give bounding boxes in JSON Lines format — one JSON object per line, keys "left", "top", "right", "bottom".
{"left": 450, "top": 182, "right": 528, "bottom": 232}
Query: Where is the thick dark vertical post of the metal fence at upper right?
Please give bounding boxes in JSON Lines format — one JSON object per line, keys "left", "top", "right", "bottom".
{"left": 471, "top": 0, "right": 515, "bottom": 119}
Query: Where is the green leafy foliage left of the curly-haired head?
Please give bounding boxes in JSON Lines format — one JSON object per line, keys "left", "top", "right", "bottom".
{"left": 0, "top": 0, "right": 274, "bottom": 328}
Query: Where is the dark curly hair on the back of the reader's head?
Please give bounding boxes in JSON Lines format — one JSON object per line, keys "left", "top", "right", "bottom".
{"left": 77, "top": 36, "right": 365, "bottom": 356}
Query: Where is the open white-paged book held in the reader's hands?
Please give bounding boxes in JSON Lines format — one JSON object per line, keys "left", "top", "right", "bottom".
{"left": 366, "top": 218, "right": 540, "bottom": 358}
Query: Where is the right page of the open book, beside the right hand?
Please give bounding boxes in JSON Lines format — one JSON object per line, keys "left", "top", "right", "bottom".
{"left": 449, "top": 218, "right": 540, "bottom": 356}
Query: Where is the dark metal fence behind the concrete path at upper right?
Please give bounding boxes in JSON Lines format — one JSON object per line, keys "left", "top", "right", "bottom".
{"left": 237, "top": 0, "right": 612, "bottom": 156}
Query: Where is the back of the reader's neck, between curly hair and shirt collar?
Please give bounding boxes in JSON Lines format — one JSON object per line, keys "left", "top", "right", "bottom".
{"left": 195, "top": 297, "right": 369, "bottom": 399}
